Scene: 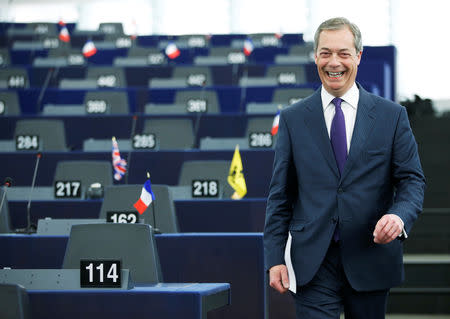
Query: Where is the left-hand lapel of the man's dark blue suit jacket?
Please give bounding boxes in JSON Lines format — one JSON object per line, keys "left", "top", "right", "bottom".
{"left": 304, "top": 88, "right": 339, "bottom": 177}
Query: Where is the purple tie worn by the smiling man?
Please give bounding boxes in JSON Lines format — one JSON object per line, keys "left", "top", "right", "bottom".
{"left": 330, "top": 97, "right": 347, "bottom": 242}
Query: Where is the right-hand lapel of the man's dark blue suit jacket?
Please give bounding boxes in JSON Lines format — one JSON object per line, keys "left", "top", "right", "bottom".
{"left": 341, "top": 85, "right": 376, "bottom": 180}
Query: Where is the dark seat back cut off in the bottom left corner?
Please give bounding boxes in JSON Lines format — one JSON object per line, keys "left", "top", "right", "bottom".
{"left": 0, "top": 283, "right": 31, "bottom": 319}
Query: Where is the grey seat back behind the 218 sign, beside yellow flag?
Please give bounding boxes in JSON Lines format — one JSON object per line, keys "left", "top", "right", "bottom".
{"left": 178, "top": 160, "right": 234, "bottom": 198}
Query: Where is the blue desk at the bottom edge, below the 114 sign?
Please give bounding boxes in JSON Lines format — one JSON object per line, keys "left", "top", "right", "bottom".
{"left": 27, "top": 283, "right": 230, "bottom": 319}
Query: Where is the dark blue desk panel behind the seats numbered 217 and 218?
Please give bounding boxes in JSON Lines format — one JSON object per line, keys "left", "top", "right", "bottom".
{"left": 0, "top": 150, "right": 274, "bottom": 199}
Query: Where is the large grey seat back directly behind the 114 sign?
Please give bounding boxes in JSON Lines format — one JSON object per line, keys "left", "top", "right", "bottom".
{"left": 62, "top": 223, "right": 162, "bottom": 284}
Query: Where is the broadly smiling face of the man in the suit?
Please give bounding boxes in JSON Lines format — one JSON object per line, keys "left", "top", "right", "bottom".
{"left": 315, "top": 28, "right": 362, "bottom": 97}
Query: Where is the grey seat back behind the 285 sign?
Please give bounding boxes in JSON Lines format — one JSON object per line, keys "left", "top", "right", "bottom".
{"left": 142, "top": 119, "right": 195, "bottom": 150}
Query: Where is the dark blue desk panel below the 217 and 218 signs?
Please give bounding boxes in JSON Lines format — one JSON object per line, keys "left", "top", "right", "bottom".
{"left": 8, "top": 198, "right": 266, "bottom": 233}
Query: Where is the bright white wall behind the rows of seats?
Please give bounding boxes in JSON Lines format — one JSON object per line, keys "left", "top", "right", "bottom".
{"left": 0, "top": 0, "right": 450, "bottom": 100}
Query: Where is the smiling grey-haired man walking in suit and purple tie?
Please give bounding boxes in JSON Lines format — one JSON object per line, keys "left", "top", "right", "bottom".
{"left": 264, "top": 18, "right": 425, "bottom": 319}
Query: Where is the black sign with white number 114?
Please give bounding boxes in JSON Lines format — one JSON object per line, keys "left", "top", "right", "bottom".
{"left": 80, "top": 259, "right": 122, "bottom": 288}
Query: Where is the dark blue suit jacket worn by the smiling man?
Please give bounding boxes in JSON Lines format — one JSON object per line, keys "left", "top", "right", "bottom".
{"left": 264, "top": 84, "right": 425, "bottom": 291}
